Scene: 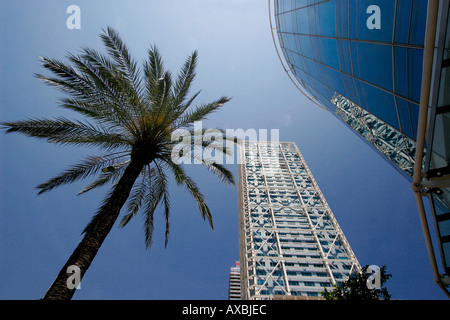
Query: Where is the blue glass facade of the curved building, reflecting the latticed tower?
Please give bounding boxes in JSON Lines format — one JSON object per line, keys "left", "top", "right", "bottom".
{"left": 275, "top": 0, "right": 427, "bottom": 178}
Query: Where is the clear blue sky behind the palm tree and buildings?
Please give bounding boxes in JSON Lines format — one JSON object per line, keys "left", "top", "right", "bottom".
{"left": 0, "top": 0, "right": 445, "bottom": 300}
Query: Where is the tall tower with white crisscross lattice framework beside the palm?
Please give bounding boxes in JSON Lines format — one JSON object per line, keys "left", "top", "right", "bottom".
{"left": 239, "top": 141, "right": 360, "bottom": 300}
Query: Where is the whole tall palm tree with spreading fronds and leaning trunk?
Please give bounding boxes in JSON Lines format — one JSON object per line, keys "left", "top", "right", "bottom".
{"left": 2, "top": 27, "right": 235, "bottom": 300}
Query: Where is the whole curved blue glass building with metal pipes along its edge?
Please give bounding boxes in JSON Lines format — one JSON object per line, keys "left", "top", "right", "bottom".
{"left": 269, "top": 0, "right": 450, "bottom": 296}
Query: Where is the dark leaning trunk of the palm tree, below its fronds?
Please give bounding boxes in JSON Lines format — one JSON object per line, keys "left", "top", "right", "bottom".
{"left": 43, "top": 161, "right": 143, "bottom": 300}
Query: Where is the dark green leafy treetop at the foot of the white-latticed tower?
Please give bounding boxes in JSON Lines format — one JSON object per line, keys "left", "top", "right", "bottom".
{"left": 321, "top": 265, "right": 392, "bottom": 301}
